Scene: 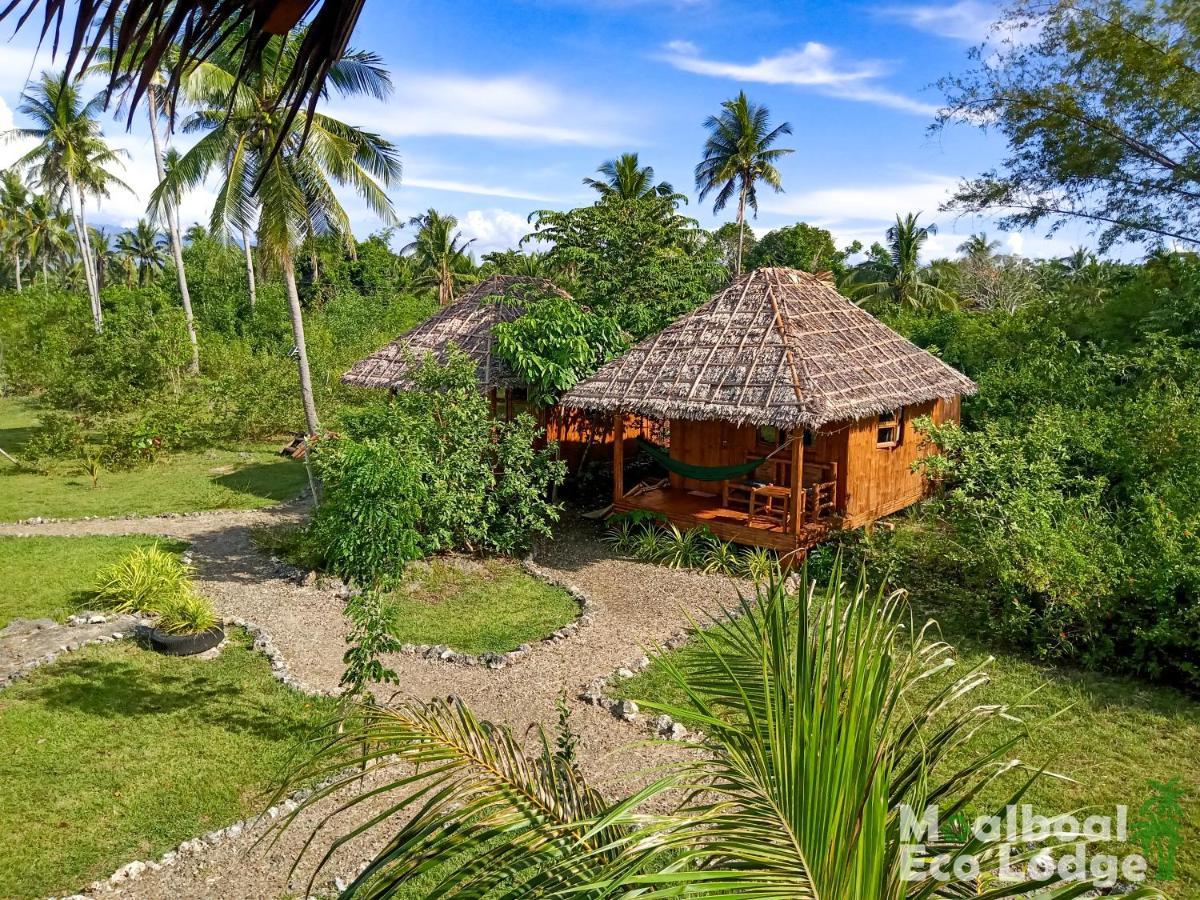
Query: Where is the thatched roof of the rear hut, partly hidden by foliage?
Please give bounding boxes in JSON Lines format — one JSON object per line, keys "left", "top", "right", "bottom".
{"left": 342, "top": 275, "right": 569, "bottom": 391}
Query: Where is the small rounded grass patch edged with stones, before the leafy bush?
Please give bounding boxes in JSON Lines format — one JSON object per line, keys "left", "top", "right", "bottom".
{"left": 386, "top": 559, "right": 578, "bottom": 654}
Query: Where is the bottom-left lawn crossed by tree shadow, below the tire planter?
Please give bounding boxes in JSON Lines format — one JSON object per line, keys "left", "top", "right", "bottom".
{"left": 0, "top": 635, "right": 332, "bottom": 896}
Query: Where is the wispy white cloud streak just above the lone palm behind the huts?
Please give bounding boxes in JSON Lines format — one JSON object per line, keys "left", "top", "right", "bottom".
{"left": 662, "top": 41, "right": 937, "bottom": 115}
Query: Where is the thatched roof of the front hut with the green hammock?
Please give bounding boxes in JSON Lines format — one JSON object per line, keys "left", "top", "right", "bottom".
{"left": 562, "top": 269, "right": 976, "bottom": 428}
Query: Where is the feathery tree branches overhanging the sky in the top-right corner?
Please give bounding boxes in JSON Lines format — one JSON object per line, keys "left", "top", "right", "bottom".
{"left": 936, "top": 0, "right": 1200, "bottom": 251}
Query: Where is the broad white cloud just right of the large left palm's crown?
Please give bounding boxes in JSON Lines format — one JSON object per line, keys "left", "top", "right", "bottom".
{"left": 329, "top": 73, "right": 628, "bottom": 146}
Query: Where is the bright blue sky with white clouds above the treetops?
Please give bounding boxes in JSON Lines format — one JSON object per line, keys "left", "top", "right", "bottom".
{"left": 0, "top": 0, "right": 1104, "bottom": 256}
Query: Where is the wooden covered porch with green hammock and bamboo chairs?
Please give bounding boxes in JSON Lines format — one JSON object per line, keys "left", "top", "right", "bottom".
{"left": 613, "top": 415, "right": 846, "bottom": 553}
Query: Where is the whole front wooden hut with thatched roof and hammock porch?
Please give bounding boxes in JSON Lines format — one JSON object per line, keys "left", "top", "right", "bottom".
{"left": 562, "top": 269, "right": 976, "bottom": 550}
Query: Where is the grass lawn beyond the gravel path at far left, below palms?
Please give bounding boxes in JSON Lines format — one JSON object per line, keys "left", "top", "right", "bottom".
{"left": 0, "top": 397, "right": 307, "bottom": 522}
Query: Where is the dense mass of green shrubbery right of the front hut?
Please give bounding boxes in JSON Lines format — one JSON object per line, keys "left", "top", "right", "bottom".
{"left": 888, "top": 267, "right": 1200, "bottom": 690}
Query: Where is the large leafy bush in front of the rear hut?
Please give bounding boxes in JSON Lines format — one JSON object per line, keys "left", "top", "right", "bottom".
{"left": 312, "top": 355, "right": 564, "bottom": 587}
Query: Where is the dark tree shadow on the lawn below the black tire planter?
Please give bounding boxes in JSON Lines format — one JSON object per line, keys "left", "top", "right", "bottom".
{"left": 23, "top": 650, "right": 319, "bottom": 740}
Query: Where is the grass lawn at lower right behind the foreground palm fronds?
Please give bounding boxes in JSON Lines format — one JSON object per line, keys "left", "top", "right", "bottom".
{"left": 612, "top": 595, "right": 1200, "bottom": 898}
